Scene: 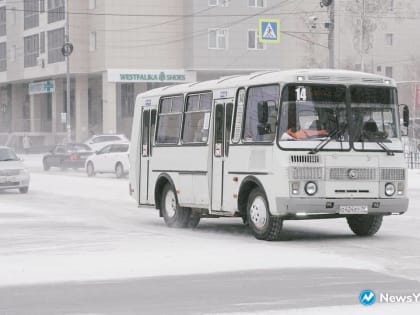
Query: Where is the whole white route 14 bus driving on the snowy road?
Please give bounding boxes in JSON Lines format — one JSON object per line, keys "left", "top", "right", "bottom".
{"left": 130, "top": 69, "right": 408, "bottom": 240}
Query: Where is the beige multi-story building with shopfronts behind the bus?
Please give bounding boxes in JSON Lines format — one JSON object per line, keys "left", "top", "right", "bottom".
{"left": 0, "top": 0, "right": 420, "bottom": 151}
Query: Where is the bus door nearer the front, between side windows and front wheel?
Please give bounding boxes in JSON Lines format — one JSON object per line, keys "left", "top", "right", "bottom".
{"left": 211, "top": 99, "right": 233, "bottom": 211}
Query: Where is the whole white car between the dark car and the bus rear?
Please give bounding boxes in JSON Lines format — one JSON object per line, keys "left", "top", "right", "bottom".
{"left": 85, "top": 143, "right": 130, "bottom": 178}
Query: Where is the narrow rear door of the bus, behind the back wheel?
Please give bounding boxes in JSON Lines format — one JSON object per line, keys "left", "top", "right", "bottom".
{"left": 139, "top": 109, "right": 156, "bottom": 204}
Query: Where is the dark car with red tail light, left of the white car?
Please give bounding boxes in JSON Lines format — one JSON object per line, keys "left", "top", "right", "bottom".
{"left": 42, "top": 143, "right": 93, "bottom": 171}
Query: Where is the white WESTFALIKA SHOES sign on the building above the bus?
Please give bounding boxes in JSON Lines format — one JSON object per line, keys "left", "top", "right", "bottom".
{"left": 108, "top": 69, "right": 196, "bottom": 83}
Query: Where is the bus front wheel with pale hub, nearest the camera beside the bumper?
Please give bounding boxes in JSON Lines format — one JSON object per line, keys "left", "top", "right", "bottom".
{"left": 247, "top": 187, "right": 283, "bottom": 241}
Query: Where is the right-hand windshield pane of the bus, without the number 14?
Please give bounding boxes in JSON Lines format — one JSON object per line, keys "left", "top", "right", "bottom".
{"left": 350, "top": 86, "right": 399, "bottom": 148}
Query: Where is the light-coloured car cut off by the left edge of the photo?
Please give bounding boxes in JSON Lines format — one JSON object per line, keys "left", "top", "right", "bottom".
{"left": 0, "top": 146, "right": 30, "bottom": 194}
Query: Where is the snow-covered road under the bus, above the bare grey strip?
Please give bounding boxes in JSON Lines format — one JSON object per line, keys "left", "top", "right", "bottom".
{"left": 0, "top": 156, "right": 420, "bottom": 314}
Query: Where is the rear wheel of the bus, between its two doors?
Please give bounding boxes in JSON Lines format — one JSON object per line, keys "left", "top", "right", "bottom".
{"left": 160, "top": 184, "right": 191, "bottom": 228}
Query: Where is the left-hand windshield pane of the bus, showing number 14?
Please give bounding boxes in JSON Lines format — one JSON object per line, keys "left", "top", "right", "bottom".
{"left": 279, "top": 85, "right": 348, "bottom": 147}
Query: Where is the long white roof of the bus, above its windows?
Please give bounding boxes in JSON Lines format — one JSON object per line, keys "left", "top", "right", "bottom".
{"left": 138, "top": 69, "right": 396, "bottom": 105}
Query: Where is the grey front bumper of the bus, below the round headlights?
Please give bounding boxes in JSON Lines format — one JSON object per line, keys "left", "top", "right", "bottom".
{"left": 272, "top": 197, "right": 408, "bottom": 216}
